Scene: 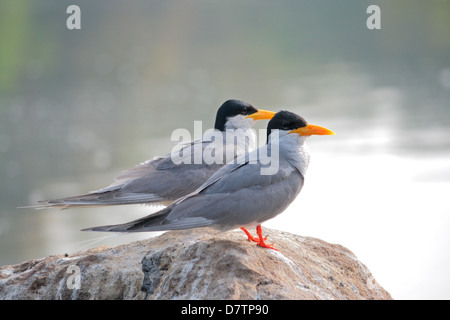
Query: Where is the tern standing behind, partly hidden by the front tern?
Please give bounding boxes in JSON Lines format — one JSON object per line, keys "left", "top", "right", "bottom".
{"left": 36, "top": 100, "right": 275, "bottom": 209}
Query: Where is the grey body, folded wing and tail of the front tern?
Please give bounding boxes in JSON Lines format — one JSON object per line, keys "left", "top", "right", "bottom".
{"left": 82, "top": 157, "right": 304, "bottom": 232}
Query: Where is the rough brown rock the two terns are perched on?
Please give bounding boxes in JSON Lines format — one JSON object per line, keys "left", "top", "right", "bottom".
{"left": 0, "top": 228, "right": 392, "bottom": 300}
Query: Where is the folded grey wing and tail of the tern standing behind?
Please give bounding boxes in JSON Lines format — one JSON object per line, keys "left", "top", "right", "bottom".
{"left": 41, "top": 141, "right": 223, "bottom": 208}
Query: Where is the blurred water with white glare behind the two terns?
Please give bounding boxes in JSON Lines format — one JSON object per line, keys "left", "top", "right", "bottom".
{"left": 0, "top": 0, "right": 450, "bottom": 299}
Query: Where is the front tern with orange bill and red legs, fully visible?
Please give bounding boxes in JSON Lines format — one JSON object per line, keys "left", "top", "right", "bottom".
{"left": 83, "top": 111, "right": 334, "bottom": 250}
